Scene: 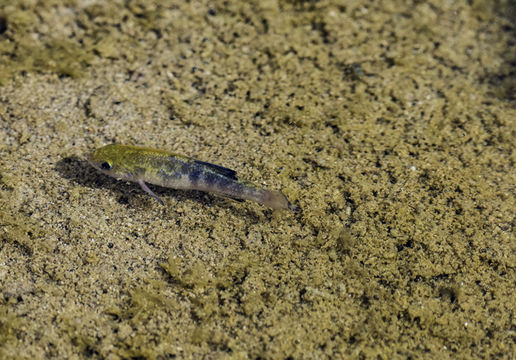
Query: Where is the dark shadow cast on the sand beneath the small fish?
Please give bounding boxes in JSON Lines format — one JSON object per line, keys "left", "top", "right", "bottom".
{"left": 54, "top": 156, "right": 266, "bottom": 219}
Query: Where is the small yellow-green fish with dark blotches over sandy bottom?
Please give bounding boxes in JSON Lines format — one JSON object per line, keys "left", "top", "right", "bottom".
{"left": 88, "top": 144, "right": 299, "bottom": 211}
